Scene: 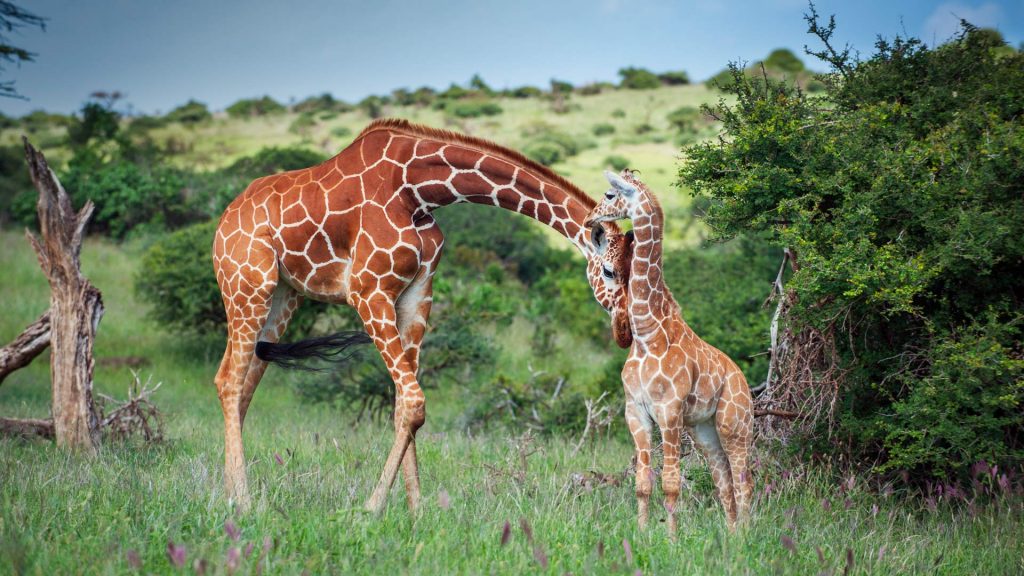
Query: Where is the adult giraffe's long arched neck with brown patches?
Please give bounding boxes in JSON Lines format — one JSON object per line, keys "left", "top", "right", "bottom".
{"left": 395, "top": 134, "right": 591, "bottom": 255}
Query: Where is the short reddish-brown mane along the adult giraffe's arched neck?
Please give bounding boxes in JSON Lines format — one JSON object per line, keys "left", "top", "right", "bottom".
{"left": 355, "top": 118, "right": 620, "bottom": 233}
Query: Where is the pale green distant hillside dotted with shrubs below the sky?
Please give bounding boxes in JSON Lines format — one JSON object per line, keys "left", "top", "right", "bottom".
{"left": 0, "top": 56, "right": 809, "bottom": 247}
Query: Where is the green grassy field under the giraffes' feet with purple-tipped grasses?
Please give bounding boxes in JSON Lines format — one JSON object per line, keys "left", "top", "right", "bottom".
{"left": 0, "top": 232, "right": 1024, "bottom": 574}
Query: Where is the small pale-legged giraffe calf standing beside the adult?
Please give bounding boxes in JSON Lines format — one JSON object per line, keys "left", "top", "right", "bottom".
{"left": 587, "top": 170, "right": 754, "bottom": 534}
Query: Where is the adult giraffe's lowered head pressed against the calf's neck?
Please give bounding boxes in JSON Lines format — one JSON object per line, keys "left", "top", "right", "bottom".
{"left": 591, "top": 223, "right": 633, "bottom": 348}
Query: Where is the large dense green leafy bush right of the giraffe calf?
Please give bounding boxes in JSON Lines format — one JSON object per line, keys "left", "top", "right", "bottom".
{"left": 680, "top": 17, "right": 1024, "bottom": 479}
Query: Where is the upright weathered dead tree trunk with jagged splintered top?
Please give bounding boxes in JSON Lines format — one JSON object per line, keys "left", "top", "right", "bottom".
{"left": 24, "top": 138, "right": 103, "bottom": 453}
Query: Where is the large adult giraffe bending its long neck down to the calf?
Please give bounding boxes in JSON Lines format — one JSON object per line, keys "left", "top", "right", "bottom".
{"left": 213, "top": 119, "right": 618, "bottom": 511}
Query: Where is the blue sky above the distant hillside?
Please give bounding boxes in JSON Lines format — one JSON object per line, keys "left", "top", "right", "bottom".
{"left": 0, "top": 0, "right": 1024, "bottom": 116}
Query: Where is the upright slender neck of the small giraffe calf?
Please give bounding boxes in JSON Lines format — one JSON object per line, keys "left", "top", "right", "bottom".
{"left": 629, "top": 190, "right": 675, "bottom": 340}
